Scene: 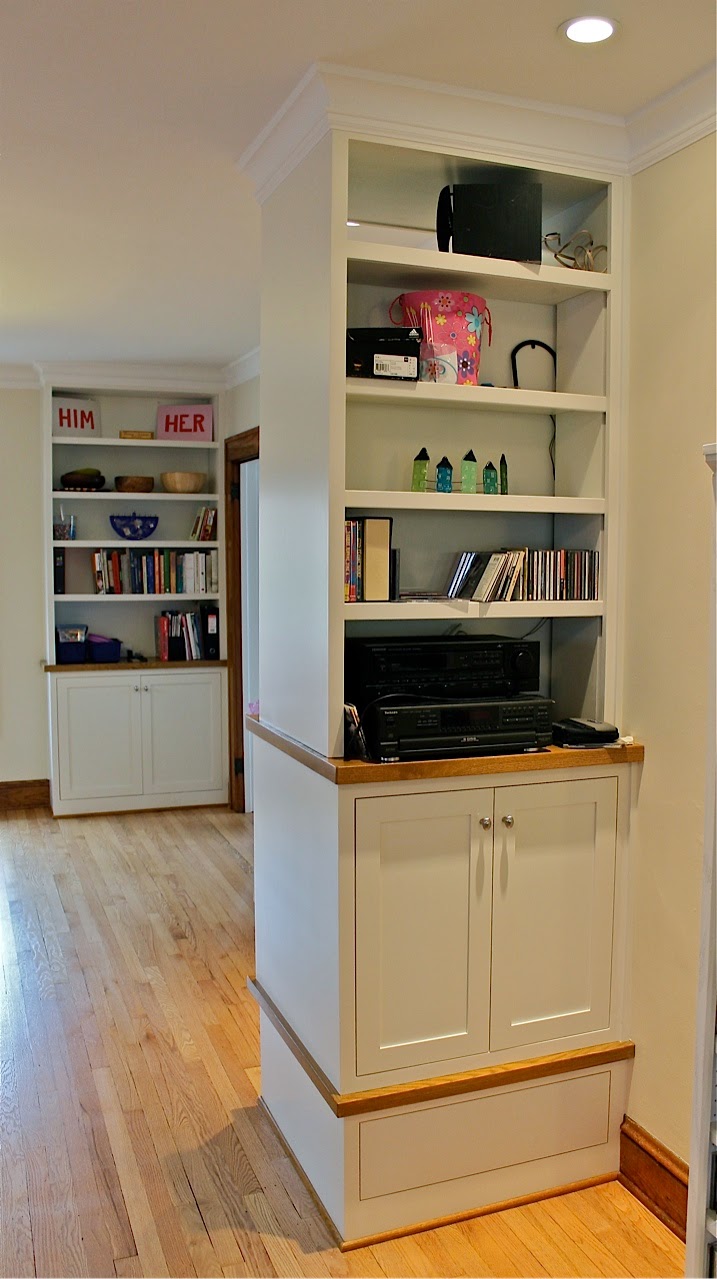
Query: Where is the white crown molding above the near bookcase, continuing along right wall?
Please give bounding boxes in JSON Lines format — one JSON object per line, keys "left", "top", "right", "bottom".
{"left": 239, "top": 63, "right": 716, "bottom": 203}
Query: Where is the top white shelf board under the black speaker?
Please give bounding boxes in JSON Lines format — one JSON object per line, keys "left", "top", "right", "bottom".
{"left": 346, "top": 240, "right": 612, "bottom": 306}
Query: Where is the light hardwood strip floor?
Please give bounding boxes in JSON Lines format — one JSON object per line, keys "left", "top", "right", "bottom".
{"left": 0, "top": 810, "right": 684, "bottom": 1279}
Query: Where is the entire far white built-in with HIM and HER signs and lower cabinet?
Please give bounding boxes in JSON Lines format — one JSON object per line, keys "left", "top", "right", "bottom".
{"left": 45, "top": 365, "right": 229, "bottom": 815}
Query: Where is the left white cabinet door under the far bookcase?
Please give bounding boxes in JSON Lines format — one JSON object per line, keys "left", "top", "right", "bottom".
{"left": 56, "top": 674, "right": 142, "bottom": 799}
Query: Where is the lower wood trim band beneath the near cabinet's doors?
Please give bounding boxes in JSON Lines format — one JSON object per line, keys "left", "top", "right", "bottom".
{"left": 247, "top": 977, "right": 635, "bottom": 1119}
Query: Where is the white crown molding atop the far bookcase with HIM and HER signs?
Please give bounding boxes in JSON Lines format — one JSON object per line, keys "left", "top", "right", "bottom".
{"left": 35, "top": 361, "right": 226, "bottom": 395}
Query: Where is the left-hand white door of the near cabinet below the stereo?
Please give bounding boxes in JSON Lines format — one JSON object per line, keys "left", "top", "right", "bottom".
{"left": 355, "top": 789, "right": 493, "bottom": 1074}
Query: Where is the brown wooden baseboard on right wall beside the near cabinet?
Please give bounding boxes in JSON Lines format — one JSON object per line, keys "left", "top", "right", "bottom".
{"left": 619, "top": 1115, "right": 689, "bottom": 1242}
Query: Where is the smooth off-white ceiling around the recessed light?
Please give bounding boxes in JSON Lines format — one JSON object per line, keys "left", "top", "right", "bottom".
{"left": 0, "top": 0, "right": 714, "bottom": 363}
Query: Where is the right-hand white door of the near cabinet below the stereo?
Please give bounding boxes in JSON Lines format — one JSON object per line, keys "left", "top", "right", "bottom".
{"left": 491, "top": 778, "right": 617, "bottom": 1050}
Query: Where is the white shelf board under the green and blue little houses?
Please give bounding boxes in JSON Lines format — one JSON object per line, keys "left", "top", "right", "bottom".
{"left": 345, "top": 489, "right": 605, "bottom": 515}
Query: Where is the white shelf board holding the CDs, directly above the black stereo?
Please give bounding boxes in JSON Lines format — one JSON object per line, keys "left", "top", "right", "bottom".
{"left": 344, "top": 600, "right": 603, "bottom": 622}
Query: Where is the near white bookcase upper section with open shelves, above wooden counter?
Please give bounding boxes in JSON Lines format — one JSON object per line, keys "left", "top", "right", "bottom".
{"left": 255, "top": 130, "right": 624, "bottom": 755}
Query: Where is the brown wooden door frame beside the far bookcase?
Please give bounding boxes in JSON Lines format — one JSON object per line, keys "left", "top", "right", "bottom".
{"left": 224, "top": 426, "right": 259, "bottom": 812}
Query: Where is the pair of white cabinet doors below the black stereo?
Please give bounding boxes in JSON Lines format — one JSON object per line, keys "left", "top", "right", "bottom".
{"left": 355, "top": 778, "right": 617, "bottom": 1074}
